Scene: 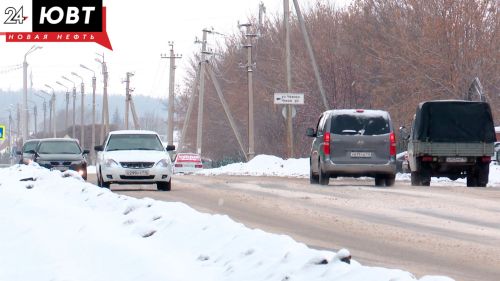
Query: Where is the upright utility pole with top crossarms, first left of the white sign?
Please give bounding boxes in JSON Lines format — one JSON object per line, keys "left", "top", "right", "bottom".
{"left": 239, "top": 23, "right": 257, "bottom": 160}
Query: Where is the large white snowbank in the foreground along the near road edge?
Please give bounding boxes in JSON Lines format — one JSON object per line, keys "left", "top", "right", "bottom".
{"left": 0, "top": 165, "right": 452, "bottom": 281}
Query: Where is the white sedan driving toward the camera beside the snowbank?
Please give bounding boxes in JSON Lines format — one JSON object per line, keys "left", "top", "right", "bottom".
{"left": 95, "top": 130, "right": 175, "bottom": 191}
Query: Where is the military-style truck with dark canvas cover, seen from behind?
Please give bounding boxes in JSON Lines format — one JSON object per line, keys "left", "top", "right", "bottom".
{"left": 408, "top": 100, "right": 496, "bottom": 187}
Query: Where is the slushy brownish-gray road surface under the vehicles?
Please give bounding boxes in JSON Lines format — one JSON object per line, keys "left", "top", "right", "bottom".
{"left": 89, "top": 175, "right": 500, "bottom": 281}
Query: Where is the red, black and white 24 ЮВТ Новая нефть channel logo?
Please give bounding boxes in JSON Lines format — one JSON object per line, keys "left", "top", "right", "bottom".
{"left": 0, "top": 0, "right": 112, "bottom": 50}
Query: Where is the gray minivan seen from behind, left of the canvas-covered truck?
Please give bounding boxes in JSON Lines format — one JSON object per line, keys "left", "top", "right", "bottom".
{"left": 306, "top": 109, "right": 396, "bottom": 186}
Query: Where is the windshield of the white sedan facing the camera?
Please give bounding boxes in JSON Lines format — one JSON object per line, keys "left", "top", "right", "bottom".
{"left": 106, "top": 134, "right": 165, "bottom": 151}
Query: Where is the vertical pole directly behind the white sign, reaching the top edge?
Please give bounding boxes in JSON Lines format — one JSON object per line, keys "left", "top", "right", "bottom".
{"left": 283, "top": 0, "right": 294, "bottom": 158}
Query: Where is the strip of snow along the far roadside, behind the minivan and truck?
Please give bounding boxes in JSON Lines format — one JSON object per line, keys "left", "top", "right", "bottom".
{"left": 197, "top": 155, "right": 500, "bottom": 186}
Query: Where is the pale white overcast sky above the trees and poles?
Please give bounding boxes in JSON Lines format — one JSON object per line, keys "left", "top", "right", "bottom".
{"left": 0, "top": 0, "right": 350, "bottom": 100}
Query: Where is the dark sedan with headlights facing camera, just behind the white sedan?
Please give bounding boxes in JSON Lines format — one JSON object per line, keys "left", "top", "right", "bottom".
{"left": 32, "top": 138, "right": 89, "bottom": 180}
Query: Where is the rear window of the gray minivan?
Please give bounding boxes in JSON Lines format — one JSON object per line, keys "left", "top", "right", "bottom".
{"left": 330, "top": 114, "right": 390, "bottom": 136}
